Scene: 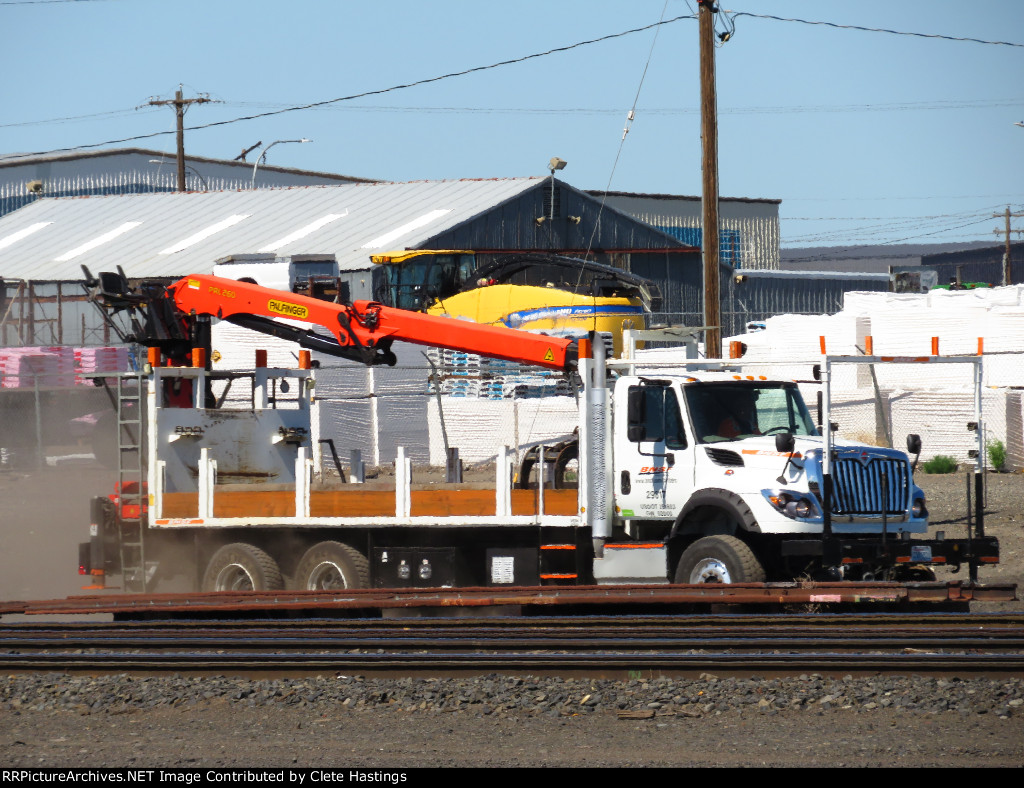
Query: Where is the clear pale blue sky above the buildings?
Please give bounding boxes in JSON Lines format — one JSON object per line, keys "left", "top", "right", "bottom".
{"left": 0, "top": 0, "right": 1024, "bottom": 246}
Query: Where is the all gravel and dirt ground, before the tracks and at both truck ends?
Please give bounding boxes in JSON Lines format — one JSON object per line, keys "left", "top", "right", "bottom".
{"left": 0, "top": 471, "right": 1024, "bottom": 768}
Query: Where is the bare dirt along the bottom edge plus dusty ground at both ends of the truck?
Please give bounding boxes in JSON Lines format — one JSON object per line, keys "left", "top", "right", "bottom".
{"left": 0, "top": 466, "right": 1024, "bottom": 769}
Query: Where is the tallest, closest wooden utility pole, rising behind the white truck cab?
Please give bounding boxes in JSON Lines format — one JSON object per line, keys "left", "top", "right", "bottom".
{"left": 697, "top": 0, "right": 722, "bottom": 358}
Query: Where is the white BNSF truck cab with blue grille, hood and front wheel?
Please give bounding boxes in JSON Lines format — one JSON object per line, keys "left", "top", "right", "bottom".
{"left": 611, "top": 370, "right": 928, "bottom": 582}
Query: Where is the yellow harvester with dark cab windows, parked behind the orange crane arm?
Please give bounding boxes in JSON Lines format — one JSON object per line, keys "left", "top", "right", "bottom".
{"left": 371, "top": 250, "right": 656, "bottom": 354}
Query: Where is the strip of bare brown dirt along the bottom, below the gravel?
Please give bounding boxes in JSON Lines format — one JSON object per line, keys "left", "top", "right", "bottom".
{"left": 0, "top": 700, "right": 1024, "bottom": 769}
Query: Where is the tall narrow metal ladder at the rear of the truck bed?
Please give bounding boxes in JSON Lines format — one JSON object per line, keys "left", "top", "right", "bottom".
{"left": 115, "top": 375, "right": 146, "bottom": 594}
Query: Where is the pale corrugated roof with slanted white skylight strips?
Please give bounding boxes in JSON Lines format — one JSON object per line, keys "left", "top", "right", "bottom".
{"left": 0, "top": 177, "right": 544, "bottom": 281}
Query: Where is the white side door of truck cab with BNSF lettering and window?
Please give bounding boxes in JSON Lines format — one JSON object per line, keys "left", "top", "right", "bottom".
{"left": 612, "top": 379, "right": 693, "bottom": 520}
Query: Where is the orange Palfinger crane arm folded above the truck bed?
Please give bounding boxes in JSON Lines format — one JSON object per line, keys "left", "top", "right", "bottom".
{"left": 85, "top": 270, "right": 577, "bottom": 370}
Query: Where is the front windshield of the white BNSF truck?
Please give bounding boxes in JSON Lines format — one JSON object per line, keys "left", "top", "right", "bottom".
{"left": 683, "top": 382, "right": 818, "bottom": 443}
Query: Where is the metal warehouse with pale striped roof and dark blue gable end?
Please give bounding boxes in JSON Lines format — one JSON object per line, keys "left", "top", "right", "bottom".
{"left": 0, "top": 177, "right": 708, "bottom": 346}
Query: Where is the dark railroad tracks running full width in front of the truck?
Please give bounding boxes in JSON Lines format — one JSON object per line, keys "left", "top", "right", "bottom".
{"left": 0, "top": 614, "right": 1024, "bottom": 675}
